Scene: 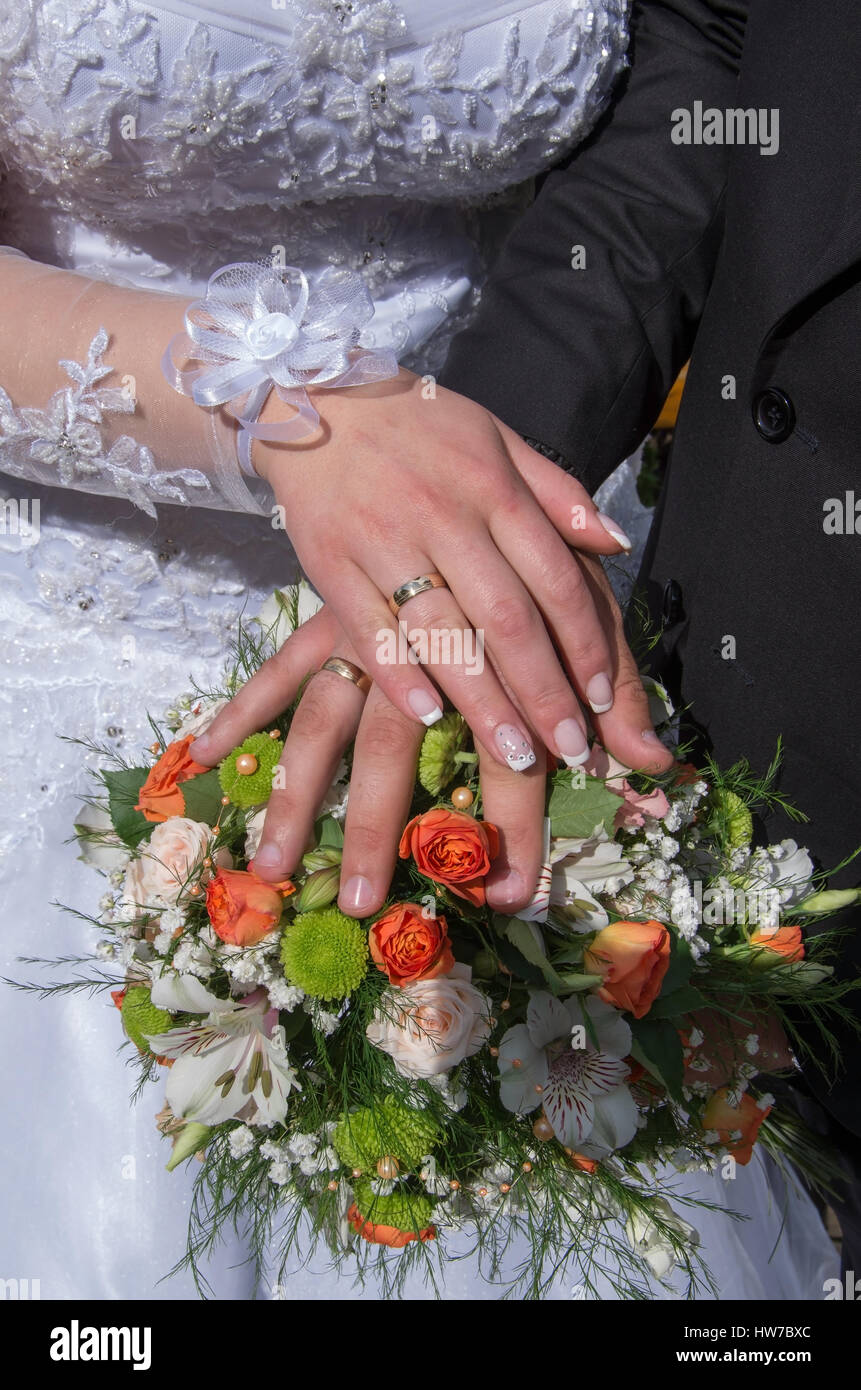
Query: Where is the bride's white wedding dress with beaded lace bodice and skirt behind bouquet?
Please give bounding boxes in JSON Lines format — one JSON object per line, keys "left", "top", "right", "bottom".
{"left": 0, "top": 0, "right": 836, "bottom": 1300}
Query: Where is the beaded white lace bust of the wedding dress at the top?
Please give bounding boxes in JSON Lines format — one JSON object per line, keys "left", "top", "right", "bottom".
{"left": 0, "top": 0, "right": 627, "bottom": 241}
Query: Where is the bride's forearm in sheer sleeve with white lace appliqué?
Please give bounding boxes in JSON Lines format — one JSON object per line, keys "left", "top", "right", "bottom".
{"left": 0, "top": 247, "right": 271, "bottom": 517}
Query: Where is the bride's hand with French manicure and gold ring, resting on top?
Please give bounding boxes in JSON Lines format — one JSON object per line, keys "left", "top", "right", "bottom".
{"left": 255, "top": 371, "right": 662, "bottom": 770}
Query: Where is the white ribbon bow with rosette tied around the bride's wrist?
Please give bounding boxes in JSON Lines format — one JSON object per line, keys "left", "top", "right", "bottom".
{"left": 161, "top": 261, "right": 398, "bottom": 478}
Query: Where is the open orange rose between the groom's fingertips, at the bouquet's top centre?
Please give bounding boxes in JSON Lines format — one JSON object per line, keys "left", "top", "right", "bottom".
{"left": 398, "top": 806, "right": 499, "bottom": 908}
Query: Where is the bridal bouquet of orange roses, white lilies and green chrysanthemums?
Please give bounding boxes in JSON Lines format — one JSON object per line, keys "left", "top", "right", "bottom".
{"left": 31, "top": 587, "right": 846, "bottom": 1297}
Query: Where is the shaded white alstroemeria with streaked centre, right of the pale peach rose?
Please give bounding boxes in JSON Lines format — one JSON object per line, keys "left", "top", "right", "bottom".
{"left": 498, "top": 990, "right": 637, "bottom": 1158}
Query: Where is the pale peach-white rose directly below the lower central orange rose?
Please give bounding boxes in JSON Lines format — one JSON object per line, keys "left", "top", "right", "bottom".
{"left": 367, "top": 965, "right": 491, "bottom": 1077}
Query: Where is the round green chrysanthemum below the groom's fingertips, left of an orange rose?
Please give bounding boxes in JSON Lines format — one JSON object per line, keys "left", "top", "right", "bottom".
{"left": 281, "top": 908, "right": 367, "bottom": 999}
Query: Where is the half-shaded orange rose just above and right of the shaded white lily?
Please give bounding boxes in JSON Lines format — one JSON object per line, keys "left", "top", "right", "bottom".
{"left": 584, "top": 922, "right": 669, "bottom": 1019}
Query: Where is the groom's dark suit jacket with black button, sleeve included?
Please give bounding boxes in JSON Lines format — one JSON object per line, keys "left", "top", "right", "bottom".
{"left": 442, "top": 0, "right": 861, "bottom": 1134}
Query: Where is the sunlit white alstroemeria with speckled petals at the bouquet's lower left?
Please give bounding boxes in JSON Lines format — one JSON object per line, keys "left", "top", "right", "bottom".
{"left": 147, "top": 990, "right": 302, "bottom": 1125}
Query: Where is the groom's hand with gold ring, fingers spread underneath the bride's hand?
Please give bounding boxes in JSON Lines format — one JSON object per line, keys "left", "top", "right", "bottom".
{"left": 191, "top": 557, "right": 672, "bottom": 917}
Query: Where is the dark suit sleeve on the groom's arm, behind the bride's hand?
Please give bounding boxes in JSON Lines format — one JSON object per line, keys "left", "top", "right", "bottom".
{"left": 441, "top": 0, "right": 753, "bottom": 489}
